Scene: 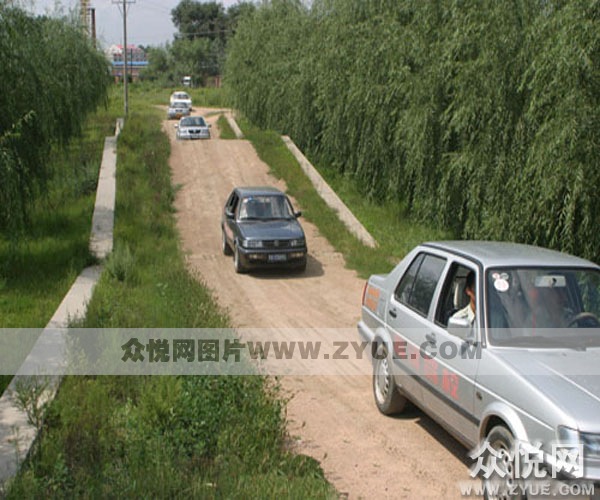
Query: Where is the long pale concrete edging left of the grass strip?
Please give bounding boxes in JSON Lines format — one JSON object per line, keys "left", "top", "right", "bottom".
{"left": 0, "top": 119, "right": 123, "bottom": 488}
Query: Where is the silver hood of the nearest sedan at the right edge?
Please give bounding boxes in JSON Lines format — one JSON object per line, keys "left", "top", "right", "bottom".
{"left": 490, "top": 348, "right": 600, "bottom": 432}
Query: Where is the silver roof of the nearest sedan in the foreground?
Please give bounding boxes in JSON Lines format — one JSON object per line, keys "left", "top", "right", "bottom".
{"left": 422, "top": 240, "right": 599, "bottom": 268}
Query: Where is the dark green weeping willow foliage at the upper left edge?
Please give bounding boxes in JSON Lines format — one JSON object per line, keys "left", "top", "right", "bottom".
{"left": 0, "top": 4, "right": 109, "bottom": 235}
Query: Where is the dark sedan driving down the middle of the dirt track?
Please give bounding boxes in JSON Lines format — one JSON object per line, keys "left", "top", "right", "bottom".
{"left": 221, "top": 187, "right": 308, "bottom": 273}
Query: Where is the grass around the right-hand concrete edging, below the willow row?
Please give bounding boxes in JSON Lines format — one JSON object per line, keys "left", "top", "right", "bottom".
{"left": 240, "top": 119, "right": 448, "bottom": 277}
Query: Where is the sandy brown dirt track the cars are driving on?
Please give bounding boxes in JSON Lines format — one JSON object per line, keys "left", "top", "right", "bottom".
{"left": 164, "top": 109, "right": 469, "bottom": 498}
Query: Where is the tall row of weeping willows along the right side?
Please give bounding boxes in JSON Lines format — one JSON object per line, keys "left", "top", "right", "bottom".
{"left": 225, "top": 0, "right": 600, "bottom": 260}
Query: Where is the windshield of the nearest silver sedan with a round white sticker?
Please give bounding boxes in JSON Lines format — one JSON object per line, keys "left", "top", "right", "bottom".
{"left": 486, "top": 267, "right": 600, "bottom": 349}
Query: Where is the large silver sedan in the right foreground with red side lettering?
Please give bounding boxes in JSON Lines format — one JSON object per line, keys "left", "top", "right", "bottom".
{"left": 358, "top": 241, "right": 600, "bottom": 498}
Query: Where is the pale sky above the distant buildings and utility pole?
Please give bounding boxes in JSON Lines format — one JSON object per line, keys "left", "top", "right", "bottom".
{"left": 23, "top": 0, "right": 244, "bottom": 48}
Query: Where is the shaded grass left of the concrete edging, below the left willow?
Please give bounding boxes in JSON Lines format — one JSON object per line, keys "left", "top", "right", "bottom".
{"left": 0, "top": 94, "right": 117, "bottom": 393}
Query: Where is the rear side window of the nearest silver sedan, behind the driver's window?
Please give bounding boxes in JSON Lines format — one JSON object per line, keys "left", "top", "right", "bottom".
{"left": 395, "top": 254, "right": 446, "bottom": 316}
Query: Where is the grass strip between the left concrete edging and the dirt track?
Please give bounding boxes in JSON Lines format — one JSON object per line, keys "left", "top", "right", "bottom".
{"left": 8, "top": 88, "right": 333, "bottom": 498}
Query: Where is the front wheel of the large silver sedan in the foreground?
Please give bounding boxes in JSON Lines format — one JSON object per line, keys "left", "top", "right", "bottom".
{"left": 483, "top": 425, "right": 525, "bottom": 500}
